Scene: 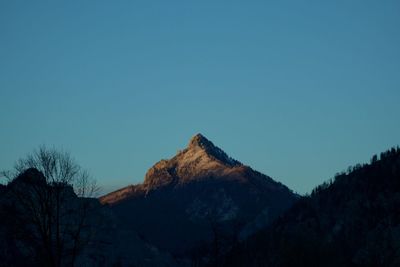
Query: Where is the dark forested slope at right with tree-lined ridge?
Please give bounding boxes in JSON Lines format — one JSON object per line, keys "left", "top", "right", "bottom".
{"left": 225, "top": 147, "right": 400, "bottom": 267}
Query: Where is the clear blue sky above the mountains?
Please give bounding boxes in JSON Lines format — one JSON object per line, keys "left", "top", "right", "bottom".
{"left": 0, "top": 0, "right": 400, "bottom": 196}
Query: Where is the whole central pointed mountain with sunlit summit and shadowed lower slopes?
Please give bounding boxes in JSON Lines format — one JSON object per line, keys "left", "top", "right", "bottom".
{"left": 100, "top": 134, "right": 297, "bottom": 257}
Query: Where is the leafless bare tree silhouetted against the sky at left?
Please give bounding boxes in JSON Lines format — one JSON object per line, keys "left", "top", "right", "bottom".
{"left": 2, "top": 146, "right": 98, "bottom": 267}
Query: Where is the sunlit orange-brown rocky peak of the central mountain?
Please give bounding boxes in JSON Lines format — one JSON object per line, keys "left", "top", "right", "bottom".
{"left": 101, "top": 133, "right": 291, "bottom": 218}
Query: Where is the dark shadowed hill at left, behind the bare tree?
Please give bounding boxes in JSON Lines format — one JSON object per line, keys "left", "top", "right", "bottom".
{"left": 0, "top": 168, "right": 177, "bottom": 267}
